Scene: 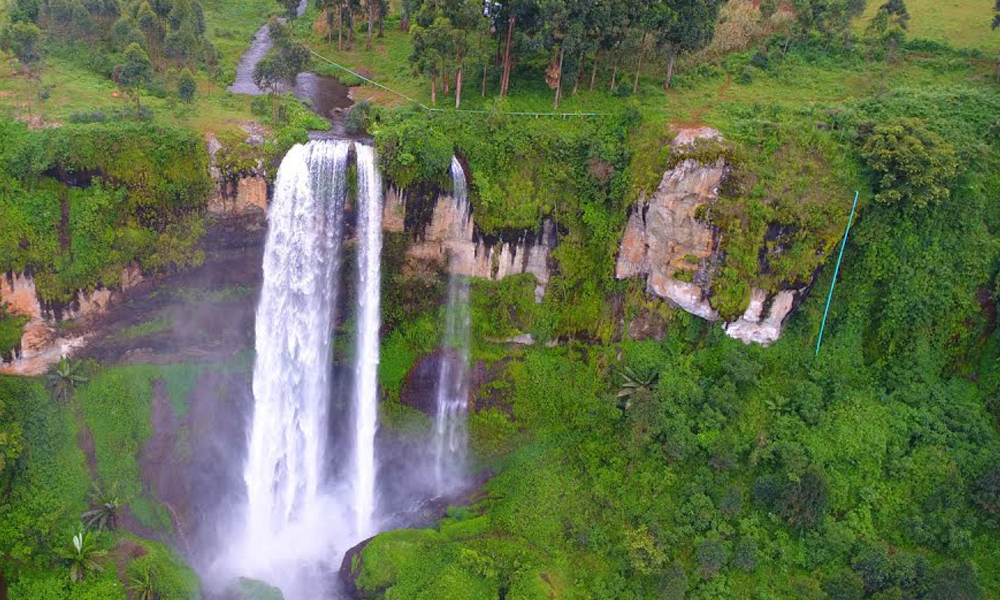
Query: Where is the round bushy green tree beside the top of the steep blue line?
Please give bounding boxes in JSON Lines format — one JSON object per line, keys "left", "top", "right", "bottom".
{"left": 861, "top": 119, "right": 958, "bottom": 212}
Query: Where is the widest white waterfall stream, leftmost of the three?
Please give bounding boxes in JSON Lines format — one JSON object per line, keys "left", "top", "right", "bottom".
{"left": 238, "top": 141, "right": 348, "bottom": 600}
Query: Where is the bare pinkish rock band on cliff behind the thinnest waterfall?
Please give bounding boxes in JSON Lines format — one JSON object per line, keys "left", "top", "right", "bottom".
{"left": 382, "top": 188, "right": 556, "bottom": 301}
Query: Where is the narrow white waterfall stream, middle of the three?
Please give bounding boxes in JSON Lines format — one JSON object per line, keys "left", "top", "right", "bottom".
{"left": 351, "top": 144, "right": 382, "bottom": 540}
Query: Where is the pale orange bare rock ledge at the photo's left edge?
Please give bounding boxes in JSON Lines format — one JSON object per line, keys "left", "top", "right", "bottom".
{"left": 0, "top": 268, "right": 142, "bottom": 375}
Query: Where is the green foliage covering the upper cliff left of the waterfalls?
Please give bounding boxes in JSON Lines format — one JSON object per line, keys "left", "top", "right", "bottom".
{"left": 0, "top": 121, "right": 211, "bottom": 301}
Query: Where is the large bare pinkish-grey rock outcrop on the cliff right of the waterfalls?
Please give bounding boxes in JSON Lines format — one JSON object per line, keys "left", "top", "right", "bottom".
{"left": 615, "top": 128, "right": 800, "bottom": 345}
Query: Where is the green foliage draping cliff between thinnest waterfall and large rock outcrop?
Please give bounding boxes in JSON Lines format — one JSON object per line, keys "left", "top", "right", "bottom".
{"left": 372, "top": 106, "right": 638, "bottom": 339}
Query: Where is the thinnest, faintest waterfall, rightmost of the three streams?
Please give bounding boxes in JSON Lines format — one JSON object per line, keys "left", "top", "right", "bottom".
{"left": 434, "top": 157, "right": 470, "bottom": 494}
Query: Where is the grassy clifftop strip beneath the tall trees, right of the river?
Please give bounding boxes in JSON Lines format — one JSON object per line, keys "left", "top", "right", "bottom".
{"left": 297, "top": 8, "right": 1000, "bottom": 133}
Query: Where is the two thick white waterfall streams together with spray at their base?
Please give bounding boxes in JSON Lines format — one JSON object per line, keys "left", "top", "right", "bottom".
{"left": 223, "top": 140, "right": 382, "bottom": 600}
